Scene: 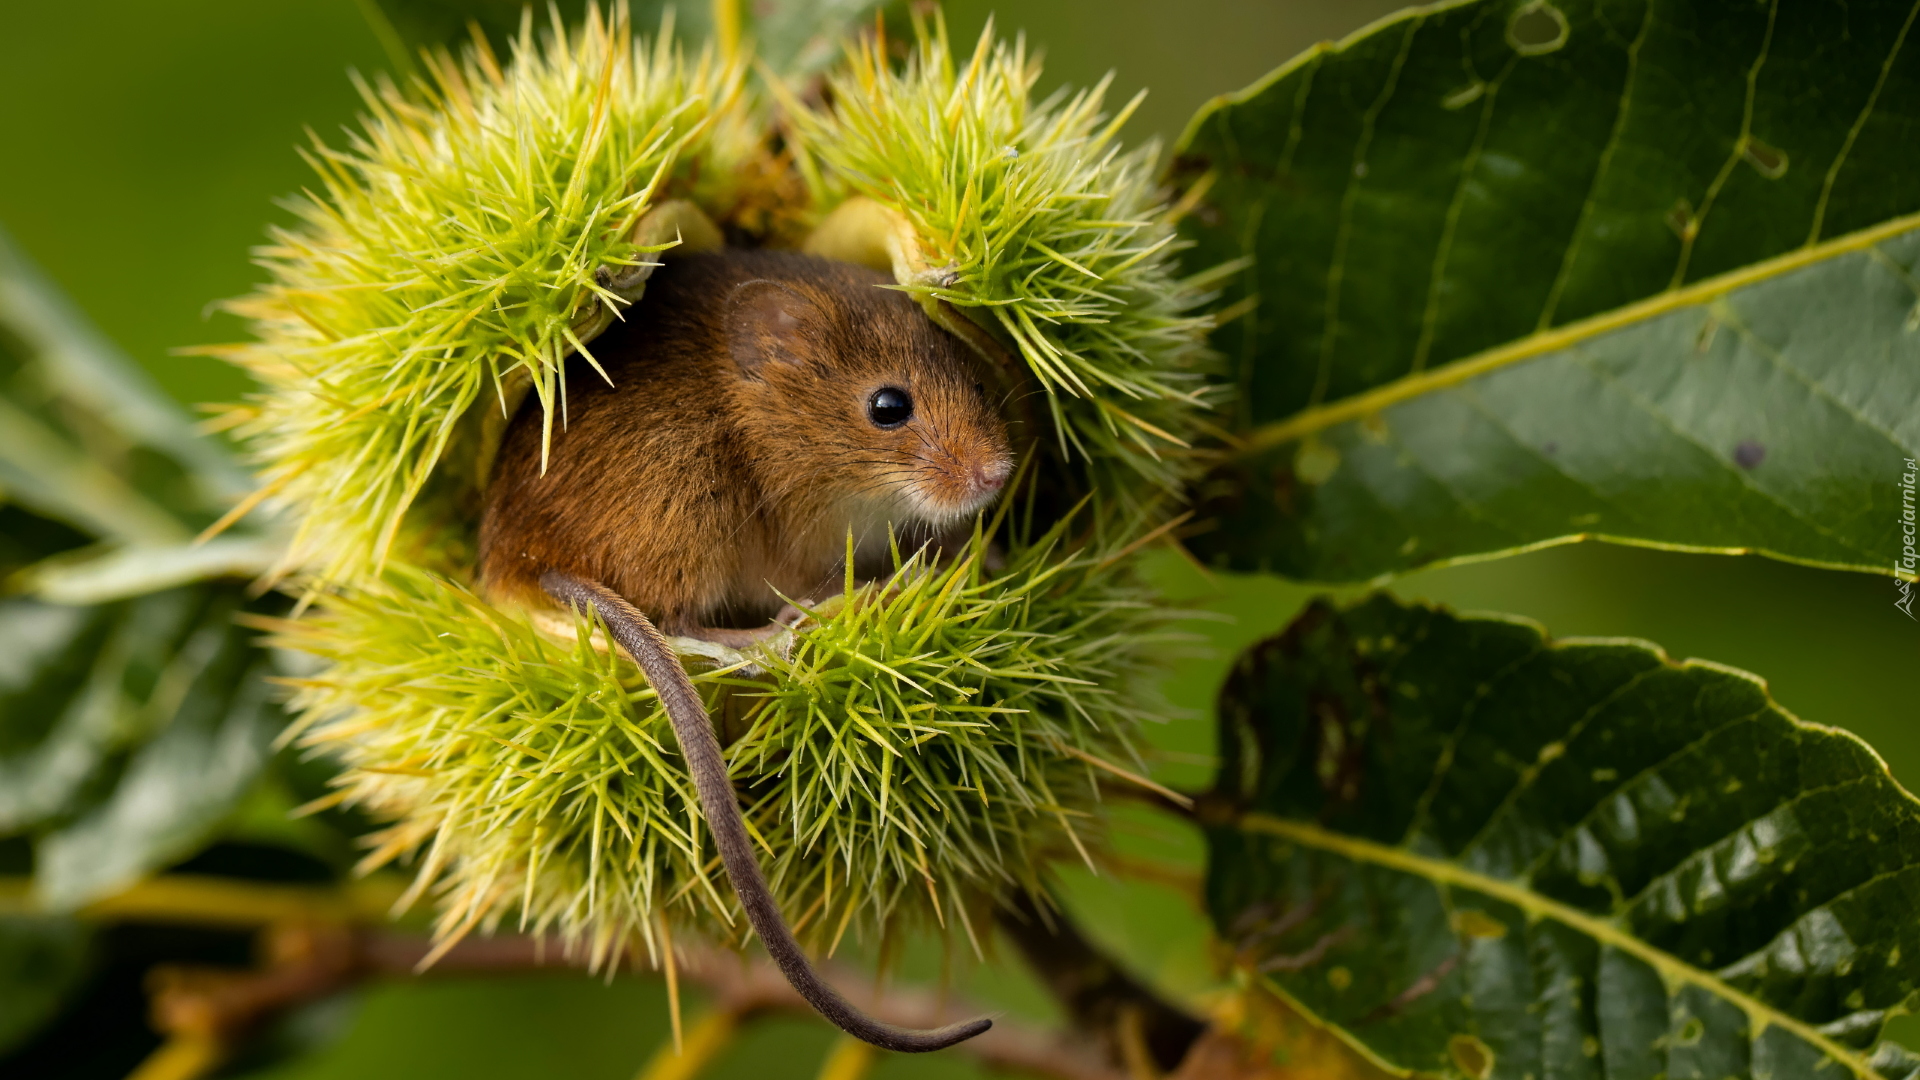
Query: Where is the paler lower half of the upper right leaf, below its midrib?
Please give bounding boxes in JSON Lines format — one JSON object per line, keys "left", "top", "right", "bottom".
{"left": 1202, "top": 224, "right": 1920, "bottom": 580}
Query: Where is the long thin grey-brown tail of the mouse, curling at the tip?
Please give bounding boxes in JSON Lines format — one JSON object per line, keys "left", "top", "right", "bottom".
{"left": 540, "top": 571, "right": 993, "bottom": 1053}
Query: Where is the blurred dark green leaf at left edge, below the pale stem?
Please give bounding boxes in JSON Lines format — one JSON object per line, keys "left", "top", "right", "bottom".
{"left": 0, "top": 586, "right": 282, "bottom": 849}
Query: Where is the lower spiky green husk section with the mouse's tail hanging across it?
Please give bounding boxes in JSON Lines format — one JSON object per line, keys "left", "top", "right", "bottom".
{"left": 268, "top": 525, "right": 1167, "bottom": 955}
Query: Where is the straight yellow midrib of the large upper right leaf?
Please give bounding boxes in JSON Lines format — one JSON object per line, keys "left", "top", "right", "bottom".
{"left": 1229, "top": 213, "right": 1920, "bottom": 457}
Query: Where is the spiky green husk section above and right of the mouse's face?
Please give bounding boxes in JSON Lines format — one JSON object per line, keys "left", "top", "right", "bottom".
{"left": 789, "top": 19, "right": 1210, "bottom": 498}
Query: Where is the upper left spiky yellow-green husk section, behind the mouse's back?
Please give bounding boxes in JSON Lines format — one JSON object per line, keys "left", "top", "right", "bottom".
{"left": 225, "top": 8, "right": 760, "bottom": 580}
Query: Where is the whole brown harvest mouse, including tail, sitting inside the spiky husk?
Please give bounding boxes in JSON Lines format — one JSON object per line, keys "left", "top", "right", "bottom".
{"left": 480, "top": 252, "right": 1012, "bottom": 1051}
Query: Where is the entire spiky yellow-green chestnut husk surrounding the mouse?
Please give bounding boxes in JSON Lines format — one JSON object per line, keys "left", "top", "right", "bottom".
{"left": 214, "top": 10, "right": 1204, "bottom": 957}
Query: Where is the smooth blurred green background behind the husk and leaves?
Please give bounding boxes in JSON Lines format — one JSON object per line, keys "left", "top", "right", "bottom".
{"left": 0, "top": 0, "right": 1920, "bottom": 1080}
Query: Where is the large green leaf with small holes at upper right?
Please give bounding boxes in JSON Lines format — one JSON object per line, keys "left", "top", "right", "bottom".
{"left": 1175, "top": 0, "right": 1920, "bottom": 580}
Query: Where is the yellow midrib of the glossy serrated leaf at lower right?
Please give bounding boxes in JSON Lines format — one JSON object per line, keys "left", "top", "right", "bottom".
{"left": 1233, "top": 813, "right": 1885, "bottom": 1080}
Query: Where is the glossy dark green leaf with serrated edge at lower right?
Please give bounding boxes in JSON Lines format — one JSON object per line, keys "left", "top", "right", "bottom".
{"left": 1208, "top": 596, "right": 1920, "bottom": 1080}
